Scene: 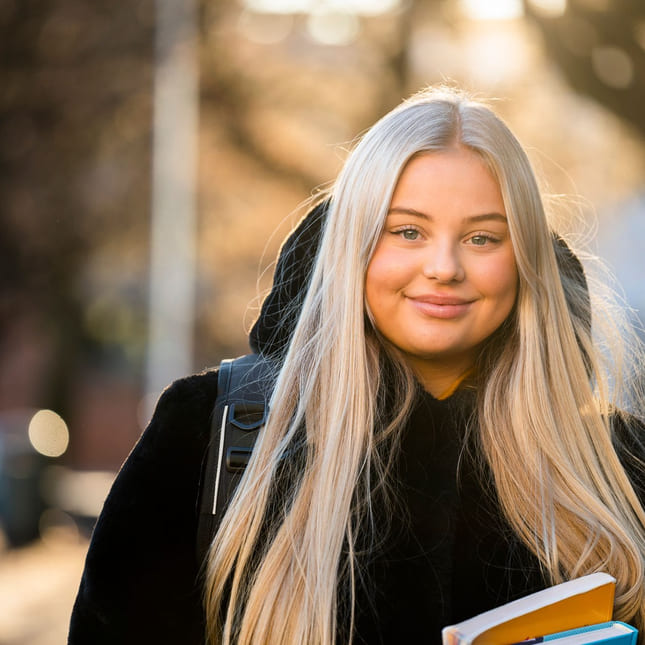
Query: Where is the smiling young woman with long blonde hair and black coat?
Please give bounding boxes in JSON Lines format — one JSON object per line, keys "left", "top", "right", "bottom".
{"left": 70, "top": 89, "right": 645, "bottom": 645}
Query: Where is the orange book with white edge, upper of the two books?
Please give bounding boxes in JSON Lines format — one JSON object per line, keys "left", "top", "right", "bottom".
{"left": 442, "top": 573, "right": 616, "bottom": 645}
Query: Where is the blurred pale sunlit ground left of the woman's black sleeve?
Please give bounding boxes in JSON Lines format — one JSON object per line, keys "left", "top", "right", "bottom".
{"left": 0, "top": 530, "right": 87, "bottom": 645}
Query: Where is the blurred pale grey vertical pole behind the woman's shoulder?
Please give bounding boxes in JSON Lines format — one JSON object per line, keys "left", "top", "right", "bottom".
{"left": 145, "top": 0, "right": 199, "bottom": 418}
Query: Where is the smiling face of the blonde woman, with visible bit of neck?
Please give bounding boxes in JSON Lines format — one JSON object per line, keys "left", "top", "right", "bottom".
{"left": 365, "top": 147, "right": 518, "bottom": 395}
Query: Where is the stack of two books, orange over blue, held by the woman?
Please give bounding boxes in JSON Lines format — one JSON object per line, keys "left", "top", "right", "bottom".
{"left": 442, "top": 573, "right": 638, "bottom": 645}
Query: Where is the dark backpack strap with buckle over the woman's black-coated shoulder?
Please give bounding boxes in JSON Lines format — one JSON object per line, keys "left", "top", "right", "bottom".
{"left": 197, "top": 354, "right": 272, "bottom": 564}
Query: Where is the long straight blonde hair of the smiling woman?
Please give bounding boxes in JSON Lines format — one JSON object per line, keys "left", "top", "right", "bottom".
{"left": 205, "top": 88, "right": 645, "bottom": 645}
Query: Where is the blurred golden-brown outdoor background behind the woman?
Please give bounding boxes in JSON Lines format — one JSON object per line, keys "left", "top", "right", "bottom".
{"left": 0, "top": 0, "right": 645, "bottom": 645}
